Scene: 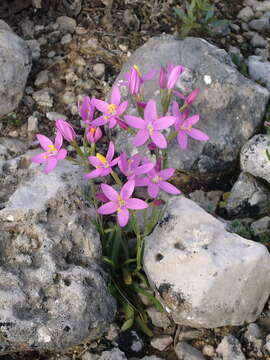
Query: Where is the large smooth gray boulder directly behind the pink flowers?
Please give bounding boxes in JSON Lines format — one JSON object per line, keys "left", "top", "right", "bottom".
{"left": 113, "top": 35, "right": 269, "bottom": 179}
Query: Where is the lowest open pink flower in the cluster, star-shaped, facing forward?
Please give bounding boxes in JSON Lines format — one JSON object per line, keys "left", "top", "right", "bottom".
{"left": 98, "top": 180, "right": 148, "bottom": 227}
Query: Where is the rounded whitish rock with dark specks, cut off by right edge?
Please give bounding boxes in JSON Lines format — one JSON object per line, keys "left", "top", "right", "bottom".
{"left": 240, "top": 134, "right": 270, "bottom": 183}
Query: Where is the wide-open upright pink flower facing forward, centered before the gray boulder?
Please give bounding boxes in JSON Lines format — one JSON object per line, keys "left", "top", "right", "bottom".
{"left": 125, "top": 99, "right": 175, "bottom": 149}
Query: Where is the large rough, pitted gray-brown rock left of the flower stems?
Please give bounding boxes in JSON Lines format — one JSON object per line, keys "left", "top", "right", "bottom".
{"left": 0, "top": 153, "right": 116, "bottom": 354}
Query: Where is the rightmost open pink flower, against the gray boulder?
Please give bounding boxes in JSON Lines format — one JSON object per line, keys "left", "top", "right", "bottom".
{"left": 172, "top": 101, "right": 209, "bottom": 149}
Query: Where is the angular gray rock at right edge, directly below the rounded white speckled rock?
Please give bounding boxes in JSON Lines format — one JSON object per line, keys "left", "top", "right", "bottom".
{"left": 226, "top": 172, "right": 270, "bottom": 217}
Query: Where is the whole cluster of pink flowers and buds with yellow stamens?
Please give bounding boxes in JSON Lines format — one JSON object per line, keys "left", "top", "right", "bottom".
{"left": 32, "top": 64, "right": 209, "bottom": 227}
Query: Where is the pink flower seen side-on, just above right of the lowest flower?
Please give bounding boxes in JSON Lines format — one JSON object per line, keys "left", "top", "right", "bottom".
{"left": 137, "top": 168, "right": 181, "bottom": 198}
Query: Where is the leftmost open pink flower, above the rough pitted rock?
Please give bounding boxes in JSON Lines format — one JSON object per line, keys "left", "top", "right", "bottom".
{"left": 31, "top": 132, "right": 67, "bottom": 174}
